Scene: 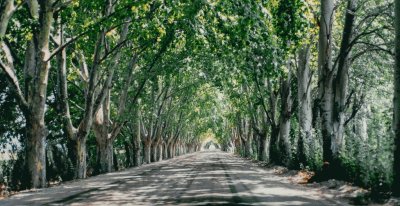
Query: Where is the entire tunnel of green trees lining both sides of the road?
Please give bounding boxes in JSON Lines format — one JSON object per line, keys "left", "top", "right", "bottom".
{"left": 0, "top": 0, "right": 400, "bottom": 198}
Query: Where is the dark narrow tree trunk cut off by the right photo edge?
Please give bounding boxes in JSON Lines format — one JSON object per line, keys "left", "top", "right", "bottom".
{"left": 393, "top": 0, "right": 400, "bottom": 196}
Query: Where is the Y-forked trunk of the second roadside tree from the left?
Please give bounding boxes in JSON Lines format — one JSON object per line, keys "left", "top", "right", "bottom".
{"left": 57, "top": 16, "right": 105, "bottom": 179}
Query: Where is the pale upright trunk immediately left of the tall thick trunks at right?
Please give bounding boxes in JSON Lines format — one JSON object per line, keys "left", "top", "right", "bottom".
{"left": 297, "top": 45, "right": 315, "bottom": 165}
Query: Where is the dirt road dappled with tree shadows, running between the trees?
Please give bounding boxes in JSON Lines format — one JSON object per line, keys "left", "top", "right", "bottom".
{"left": 0, "top": 151, "right": 344, "bottom": 205}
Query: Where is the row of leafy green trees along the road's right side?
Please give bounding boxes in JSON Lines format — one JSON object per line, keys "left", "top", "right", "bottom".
{"left": 209, "top": 0, "right": 399, "bottom": 197}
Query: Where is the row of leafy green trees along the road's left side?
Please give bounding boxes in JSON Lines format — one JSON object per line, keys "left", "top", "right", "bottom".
{"left": 0, "top": 0, "right": 219, "bottom": 188}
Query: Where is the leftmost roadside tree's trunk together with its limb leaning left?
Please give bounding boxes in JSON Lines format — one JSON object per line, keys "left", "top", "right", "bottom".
{"left": 0, "top": 0, "right": 59, "bottom": 188}
